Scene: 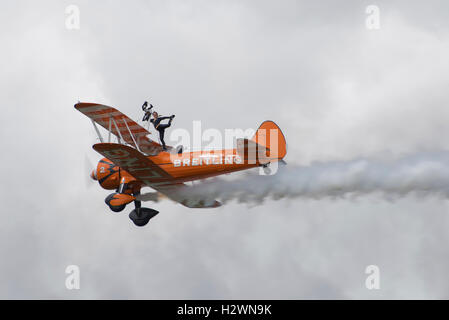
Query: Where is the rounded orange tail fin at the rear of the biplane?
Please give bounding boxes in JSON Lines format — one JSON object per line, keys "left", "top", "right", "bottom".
{"left": 251, "top": 120, "right": 287, "bottom": 160}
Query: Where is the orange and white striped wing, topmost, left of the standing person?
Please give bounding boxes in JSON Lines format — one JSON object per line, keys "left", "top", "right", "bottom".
{"left": 75, "top": 102, "right": 166, "bottom": 155}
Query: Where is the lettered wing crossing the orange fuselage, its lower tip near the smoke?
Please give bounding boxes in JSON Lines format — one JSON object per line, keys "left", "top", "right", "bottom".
{"left": 93, "top": 143, "right": 221, "bottom": 208}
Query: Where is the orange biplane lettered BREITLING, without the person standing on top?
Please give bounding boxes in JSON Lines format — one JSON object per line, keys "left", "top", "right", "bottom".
{"left": 75, "top": 102, "right": 287, "bottom": 226}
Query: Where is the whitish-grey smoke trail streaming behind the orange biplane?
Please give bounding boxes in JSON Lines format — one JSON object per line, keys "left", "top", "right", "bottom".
{"left": 179, "top": 152, "right": 449, "bottom": 204}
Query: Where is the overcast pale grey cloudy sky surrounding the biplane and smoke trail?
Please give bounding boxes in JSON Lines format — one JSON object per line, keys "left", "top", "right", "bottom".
{"left": 0, "top": 0, "right": 449, "bottom": 299}
